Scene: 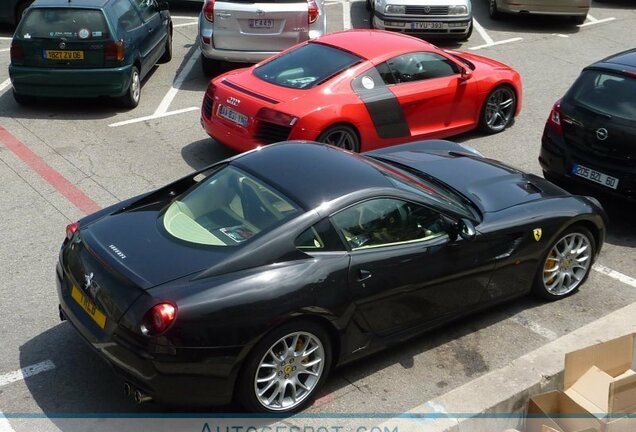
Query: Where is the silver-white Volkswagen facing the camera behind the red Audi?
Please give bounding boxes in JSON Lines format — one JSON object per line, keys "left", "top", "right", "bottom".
{"left": 367, "top": 0, "right": 473, "bottom": 40}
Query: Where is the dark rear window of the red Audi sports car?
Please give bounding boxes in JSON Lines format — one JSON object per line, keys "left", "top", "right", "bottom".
{"left": 254, "top": 43, "right": 362, "bottom": 88}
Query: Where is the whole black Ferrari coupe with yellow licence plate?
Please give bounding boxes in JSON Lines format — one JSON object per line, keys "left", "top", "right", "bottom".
{"left": 57, "top": 141, "right": 605, "bottom": 413}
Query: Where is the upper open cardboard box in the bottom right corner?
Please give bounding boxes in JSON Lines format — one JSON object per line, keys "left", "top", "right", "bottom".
{"left": 563, "top": 333, "right": 636, "bottom": 417}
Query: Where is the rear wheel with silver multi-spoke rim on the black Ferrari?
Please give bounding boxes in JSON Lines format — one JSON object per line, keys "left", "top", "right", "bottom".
{"left": 254, "top": 331, "right": 325, "bottom": 411}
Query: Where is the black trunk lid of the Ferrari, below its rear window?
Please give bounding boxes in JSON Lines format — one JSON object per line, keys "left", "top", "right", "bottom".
{"left": 80, "top": 208, "right": 229, "bottom": 289}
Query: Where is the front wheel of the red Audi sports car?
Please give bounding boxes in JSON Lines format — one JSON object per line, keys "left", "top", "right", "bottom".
{"left": 479, "top": 85, "right": 517, "bottom": 134}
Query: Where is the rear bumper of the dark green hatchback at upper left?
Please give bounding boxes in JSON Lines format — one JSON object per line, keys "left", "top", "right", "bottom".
{"left": 9, "top": 65, "right": 132, "bottom": 97}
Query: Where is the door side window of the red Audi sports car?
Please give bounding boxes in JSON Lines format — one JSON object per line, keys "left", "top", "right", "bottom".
{"left": 387, "top": 52, "right": 459, "bottom": 83}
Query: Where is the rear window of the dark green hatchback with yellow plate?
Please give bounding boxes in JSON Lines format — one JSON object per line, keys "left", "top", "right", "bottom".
{"left": 16, "top": 8, "right": 110, "bottom": 41}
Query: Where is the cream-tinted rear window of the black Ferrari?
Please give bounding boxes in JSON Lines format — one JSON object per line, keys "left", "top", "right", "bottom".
{"left": 163, "top": 166, "right": 300, "bottom": 246}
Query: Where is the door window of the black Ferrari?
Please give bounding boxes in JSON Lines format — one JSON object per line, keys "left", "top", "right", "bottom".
{"left": 332, "top": 198, "right": 446, "bottom": 250}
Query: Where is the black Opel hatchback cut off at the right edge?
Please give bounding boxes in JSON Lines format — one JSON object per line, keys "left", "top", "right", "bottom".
{"left": 539, "top": 49, "right": 636, "bottom": 201}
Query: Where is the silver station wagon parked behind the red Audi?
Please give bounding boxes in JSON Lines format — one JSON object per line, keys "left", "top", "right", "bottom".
{"left": 199, "top": 0, "right": 326, "bottom": 75}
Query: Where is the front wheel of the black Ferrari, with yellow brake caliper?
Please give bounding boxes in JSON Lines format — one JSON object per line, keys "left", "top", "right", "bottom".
{"left": 533, "top": 226, "right": 596, "bottom": 301}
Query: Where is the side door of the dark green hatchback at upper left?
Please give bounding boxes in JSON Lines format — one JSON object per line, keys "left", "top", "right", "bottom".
{"left": 130, "top": 0, "right": 166, "bottom": 71}
